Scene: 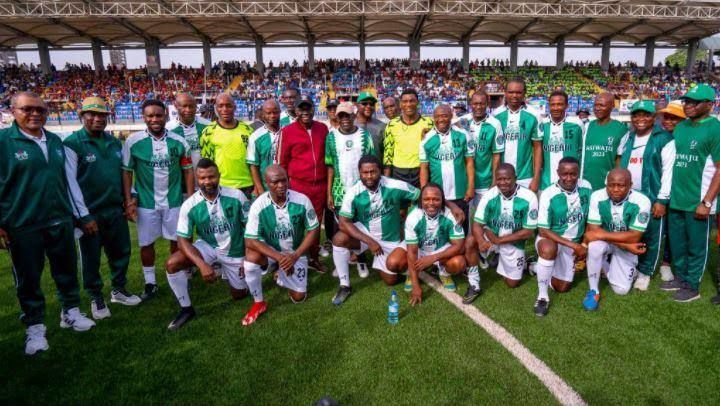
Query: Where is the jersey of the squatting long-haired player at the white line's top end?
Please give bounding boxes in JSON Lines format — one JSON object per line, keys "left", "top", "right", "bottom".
{"left": 405, "top": 207, "right": 465, "bottom": 252}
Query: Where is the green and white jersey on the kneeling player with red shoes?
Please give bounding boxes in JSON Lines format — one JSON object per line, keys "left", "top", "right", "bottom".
{"left": 245, "top": 190, "right": 320, "bottom": 252}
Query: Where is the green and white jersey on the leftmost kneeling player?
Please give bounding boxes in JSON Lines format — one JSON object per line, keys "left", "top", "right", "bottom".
{"left": 177, "top": 187, "right": 250, "bottom": 258}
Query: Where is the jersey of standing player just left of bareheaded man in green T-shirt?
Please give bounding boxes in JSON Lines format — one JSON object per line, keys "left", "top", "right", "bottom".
{"left": 540, "top": 117, "right": 583, "bottom": 190}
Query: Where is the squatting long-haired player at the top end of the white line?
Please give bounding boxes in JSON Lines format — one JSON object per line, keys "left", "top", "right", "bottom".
{"left": 405, "top": 183, "right": 465, "bottom": 306}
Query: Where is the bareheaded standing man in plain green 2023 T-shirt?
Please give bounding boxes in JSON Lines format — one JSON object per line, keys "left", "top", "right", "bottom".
{"left": 580, "top": 93, "right": 630, "bottom": 190}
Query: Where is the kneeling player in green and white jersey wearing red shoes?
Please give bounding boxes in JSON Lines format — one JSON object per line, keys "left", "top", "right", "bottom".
{"left": 242, "top": 165, "right": 324, "bottom": 326}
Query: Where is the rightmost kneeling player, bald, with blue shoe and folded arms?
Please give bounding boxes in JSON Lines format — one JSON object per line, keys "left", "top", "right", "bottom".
{"left": 583, "top": 168, "right": 651, "bottom": 310}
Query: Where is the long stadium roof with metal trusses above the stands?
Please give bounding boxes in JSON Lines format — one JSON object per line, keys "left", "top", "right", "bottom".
{"left": 0, "top": 0, "right": 720, "bottom": 48}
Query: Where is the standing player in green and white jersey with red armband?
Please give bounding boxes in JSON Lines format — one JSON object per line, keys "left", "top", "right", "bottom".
{"left": 123, "top": 99, "right": 195, "bottom": 301}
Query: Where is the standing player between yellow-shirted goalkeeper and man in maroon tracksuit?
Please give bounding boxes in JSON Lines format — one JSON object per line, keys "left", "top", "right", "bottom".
{"left": 245, "top": 99, "right": 280, "bottom": 197}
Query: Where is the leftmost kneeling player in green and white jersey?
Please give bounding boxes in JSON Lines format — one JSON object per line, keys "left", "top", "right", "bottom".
{"left": 166, "top": 158, "right": 250, "bottom": 330}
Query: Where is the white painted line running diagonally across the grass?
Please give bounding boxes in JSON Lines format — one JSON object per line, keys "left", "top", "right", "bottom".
{"left": 420, "top": 272, "right": 587, "bottom": 405}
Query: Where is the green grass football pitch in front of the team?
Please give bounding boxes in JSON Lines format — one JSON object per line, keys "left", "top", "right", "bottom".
{"left": 0, "top": 227, "right": 720, "bottom": 405}
